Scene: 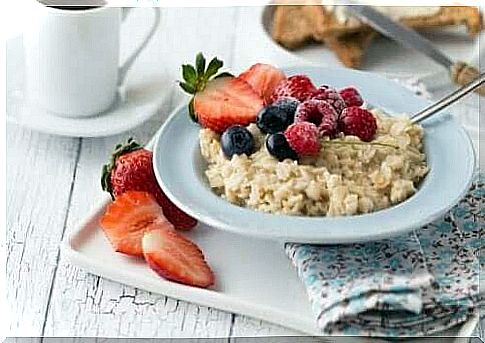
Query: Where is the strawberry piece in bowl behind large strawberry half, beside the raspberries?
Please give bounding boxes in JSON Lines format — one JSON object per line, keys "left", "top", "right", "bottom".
{"left": 238, "top": 63, "right": 286, "bottom": 104}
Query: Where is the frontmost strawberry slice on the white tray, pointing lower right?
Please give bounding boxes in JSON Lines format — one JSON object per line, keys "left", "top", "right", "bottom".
{"left": 142, "top": 230, "right": 214, "bottom": 288}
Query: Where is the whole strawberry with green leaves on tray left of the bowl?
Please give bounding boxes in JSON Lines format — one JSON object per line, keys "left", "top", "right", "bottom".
{"left": 101, "top": 138, "right": 197, "bottom": 230}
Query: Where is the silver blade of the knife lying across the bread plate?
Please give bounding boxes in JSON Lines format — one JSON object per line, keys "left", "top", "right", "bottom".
{"left": 346, "top": 5, "right": 454, "bottom": 69}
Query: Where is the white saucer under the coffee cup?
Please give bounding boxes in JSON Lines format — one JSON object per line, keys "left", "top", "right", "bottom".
{"left": 6, "top": 37, "right": 171, "bottom": 137}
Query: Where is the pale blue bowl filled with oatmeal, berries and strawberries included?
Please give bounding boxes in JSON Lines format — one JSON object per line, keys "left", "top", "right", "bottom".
{"left": 153, "top": 61, "right": 475, "bottom": 244}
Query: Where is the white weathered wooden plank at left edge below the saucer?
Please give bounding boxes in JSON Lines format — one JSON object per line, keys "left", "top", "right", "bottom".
{"left": 6, "top": 125, "right": 79, "bottom": 336}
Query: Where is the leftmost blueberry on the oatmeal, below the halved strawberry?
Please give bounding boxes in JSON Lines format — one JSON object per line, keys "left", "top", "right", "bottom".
{"left": 221, "top": 125, "right": 254, "bottom": 158}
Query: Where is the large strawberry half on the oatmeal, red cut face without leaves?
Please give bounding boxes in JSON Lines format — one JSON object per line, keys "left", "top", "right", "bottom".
{"left": 194, "top": 77, "right": 264, "bottom": 133}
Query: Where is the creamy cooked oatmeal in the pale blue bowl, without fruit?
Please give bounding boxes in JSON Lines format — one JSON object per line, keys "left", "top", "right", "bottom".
{"left": 200, "top": 110, "right": 428, "bottom": 216}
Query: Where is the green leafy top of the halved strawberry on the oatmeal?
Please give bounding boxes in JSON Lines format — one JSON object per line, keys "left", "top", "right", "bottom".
{"left": 179, "top": 52, "right": 233, "bottom": 123}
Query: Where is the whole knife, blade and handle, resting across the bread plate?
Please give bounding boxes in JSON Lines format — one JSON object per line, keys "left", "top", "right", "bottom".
{"left": 346, "top": 5, "right": 485, "bottom": 96}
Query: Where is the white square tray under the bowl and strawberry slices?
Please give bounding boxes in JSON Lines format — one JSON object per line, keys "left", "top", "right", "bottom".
{"left": 62, "top": 197, "right": 478, "bottom": 341}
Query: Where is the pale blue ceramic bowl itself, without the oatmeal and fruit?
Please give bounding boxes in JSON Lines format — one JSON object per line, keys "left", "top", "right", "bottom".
{"left": 153, "top": 67, "right": 475, "bottom": 244}
